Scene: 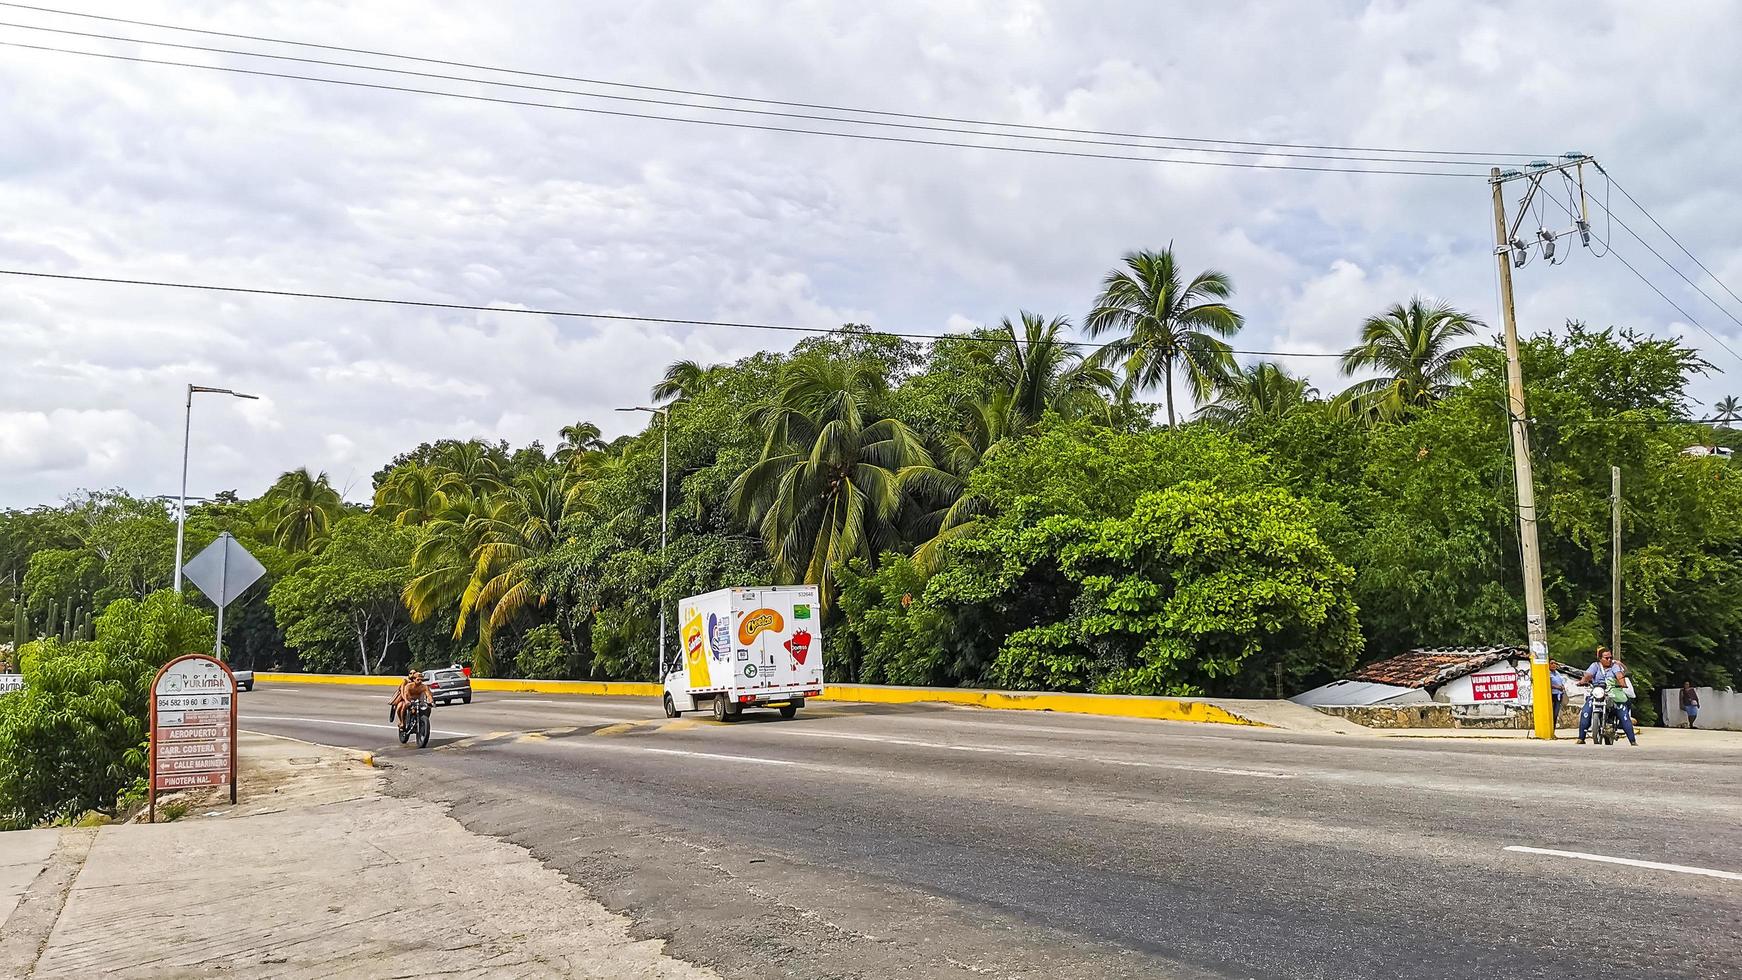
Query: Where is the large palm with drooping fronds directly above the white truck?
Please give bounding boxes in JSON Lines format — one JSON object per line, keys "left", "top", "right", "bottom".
{"left": 730, "top": 357, "right": 932, "bottom": 606}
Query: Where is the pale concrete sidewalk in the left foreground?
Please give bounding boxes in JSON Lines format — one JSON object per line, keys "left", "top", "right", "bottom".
{"left": 0, "top": 733, "right": 712, "bottom": 978}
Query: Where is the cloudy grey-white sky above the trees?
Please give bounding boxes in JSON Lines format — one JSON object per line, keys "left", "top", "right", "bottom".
{"left": 0, "top": 0, "right": 1742, "bottom": 507}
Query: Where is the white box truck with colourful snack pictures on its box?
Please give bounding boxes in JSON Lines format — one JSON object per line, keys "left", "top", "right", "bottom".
{"left": 665, "top": 585, "right": 822, "bottom": 721}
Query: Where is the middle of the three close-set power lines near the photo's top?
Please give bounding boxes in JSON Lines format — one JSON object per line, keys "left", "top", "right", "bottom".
{"left": 0, "top": 21, "right": 1519, "bottom": 167}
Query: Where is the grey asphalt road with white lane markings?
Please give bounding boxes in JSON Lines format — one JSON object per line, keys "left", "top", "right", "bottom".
{"left": 242, "top": 686, "right": 1742, "bottom": 980}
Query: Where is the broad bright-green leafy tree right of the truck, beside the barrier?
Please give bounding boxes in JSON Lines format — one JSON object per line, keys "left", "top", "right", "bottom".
{"left": 991, "top": 482, "right": 1361, "bottom": 696}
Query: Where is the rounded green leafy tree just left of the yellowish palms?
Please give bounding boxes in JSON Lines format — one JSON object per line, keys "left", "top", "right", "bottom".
{"left": 268, "top": 515, "right": 415, "bottom": 674}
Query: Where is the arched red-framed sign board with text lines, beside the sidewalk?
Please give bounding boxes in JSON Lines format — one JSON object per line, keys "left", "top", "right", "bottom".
{"left": 152, "top": 653, "right": 235, "bottom": 820}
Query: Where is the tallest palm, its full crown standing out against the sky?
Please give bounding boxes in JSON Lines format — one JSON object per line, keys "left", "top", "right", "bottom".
{"left": 1084, "top": 245, "right": 1246, "bottom": 426}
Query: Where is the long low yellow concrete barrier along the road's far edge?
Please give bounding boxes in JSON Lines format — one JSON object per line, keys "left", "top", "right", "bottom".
{"left": 254, "top": 674, "right": 1265, "bottom": 728}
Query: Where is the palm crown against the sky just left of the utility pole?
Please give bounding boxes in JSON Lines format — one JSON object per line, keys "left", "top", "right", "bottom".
{"left": 1336, "top": 296, "right": 1484, "bottom": 418}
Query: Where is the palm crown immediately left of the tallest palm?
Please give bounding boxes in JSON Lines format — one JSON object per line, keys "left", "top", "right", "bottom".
{"left": 972, "top": 310, "right": 1115, "bottom": 428}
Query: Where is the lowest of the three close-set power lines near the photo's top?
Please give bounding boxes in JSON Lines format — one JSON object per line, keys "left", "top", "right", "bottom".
{"left": 0, "top": 40, "right": 1475, "bottom": 179}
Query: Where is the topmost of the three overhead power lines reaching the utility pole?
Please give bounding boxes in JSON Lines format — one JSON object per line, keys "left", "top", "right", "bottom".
{"left": 0, "top": 2, "right": 1549, "bottom": 164}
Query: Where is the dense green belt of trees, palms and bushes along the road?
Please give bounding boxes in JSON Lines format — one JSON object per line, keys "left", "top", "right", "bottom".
{"left": 0, "top": 249, "right": 1742, "bottom": 818}
